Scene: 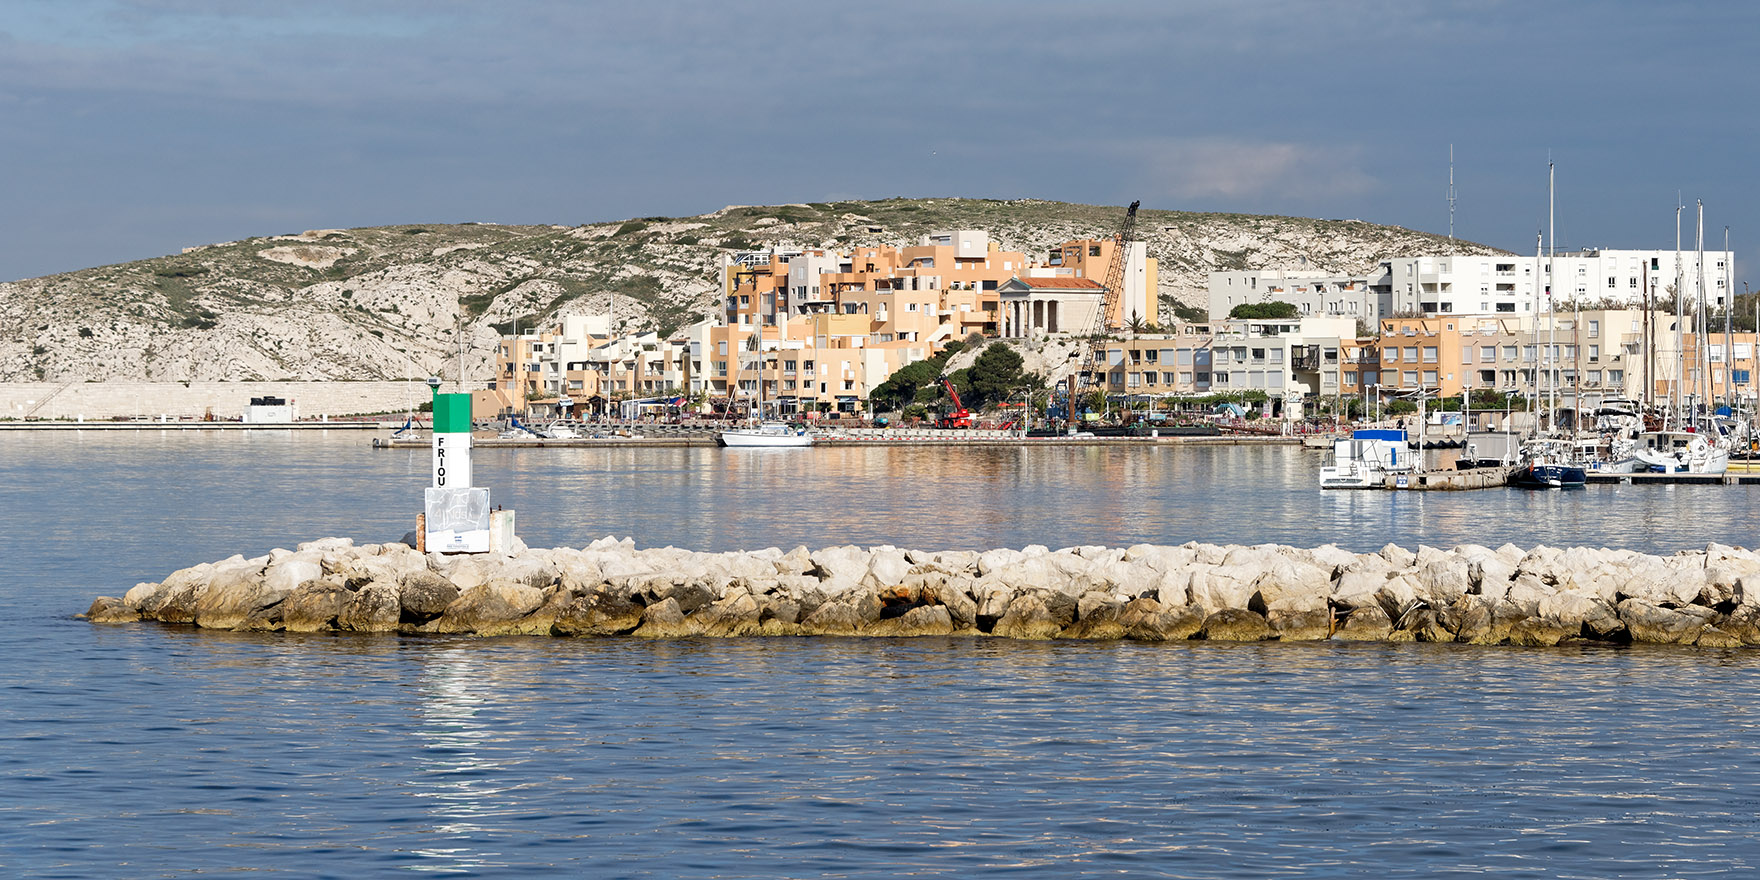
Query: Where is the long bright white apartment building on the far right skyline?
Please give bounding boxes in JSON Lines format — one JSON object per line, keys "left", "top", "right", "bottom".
{"left": 1382, "top": 248, "right": 1735, "bottom": 315}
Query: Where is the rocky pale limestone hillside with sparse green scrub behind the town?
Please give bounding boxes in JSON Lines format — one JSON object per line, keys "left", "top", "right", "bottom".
{"left": 0, "top": 199, "right": 1492, "bottom": 382}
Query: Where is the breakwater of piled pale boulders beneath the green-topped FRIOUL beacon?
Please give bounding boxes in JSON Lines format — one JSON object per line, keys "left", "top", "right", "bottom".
{"left": 86, "top": 539, "right": 1760, "bottom": 648}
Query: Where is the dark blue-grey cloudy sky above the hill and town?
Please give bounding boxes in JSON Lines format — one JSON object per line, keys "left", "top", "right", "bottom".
{"left": 0, "top": 0, "right": 1760, "bottom": 290}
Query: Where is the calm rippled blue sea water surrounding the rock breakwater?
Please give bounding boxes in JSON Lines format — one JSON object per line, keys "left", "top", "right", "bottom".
{"left": 0, "top": 433, "right": 1760, "bottom": 878}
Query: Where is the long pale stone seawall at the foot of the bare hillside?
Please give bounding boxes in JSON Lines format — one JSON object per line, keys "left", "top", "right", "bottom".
{"left": 0, "top": 382, "right": 429, "bottom": 421}
